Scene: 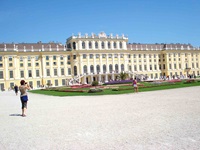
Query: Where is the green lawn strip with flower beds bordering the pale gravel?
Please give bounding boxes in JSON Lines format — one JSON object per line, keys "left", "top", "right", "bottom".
{"left": 30, "top": 81, "right": 200, "bottom": 96}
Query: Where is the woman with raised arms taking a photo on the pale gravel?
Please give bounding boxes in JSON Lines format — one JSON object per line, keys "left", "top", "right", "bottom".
{"left": 19, "top": 80, "right": 30, "bottom": 117}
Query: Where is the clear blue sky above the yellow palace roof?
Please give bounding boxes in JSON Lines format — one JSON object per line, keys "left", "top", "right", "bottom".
{"left": 0, "top": 0, "right": 200, "bottom": 46}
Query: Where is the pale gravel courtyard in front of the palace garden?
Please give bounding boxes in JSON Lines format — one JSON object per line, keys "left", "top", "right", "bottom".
{"left": 0, "top": 86, "right": 200, "bottom": 150}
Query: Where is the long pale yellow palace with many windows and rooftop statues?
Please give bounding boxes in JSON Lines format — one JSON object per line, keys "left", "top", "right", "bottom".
{"left": 0, "top": 32, "right": 200, "bottom": 90}
